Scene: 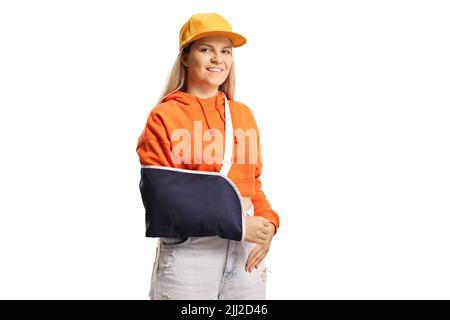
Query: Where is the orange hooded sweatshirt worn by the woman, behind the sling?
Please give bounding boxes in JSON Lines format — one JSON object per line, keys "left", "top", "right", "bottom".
{"left": 136, "top": 90, "right": 280, "bottom": 233}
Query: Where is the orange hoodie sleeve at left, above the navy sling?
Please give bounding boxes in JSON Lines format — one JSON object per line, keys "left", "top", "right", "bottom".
{"left": 136, "top": 109, "right": 176, "bottom": 167}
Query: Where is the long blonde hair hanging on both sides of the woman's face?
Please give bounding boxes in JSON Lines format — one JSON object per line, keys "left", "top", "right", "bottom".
{"left": 157, "top": 41, "right": 236, "bottom": 104}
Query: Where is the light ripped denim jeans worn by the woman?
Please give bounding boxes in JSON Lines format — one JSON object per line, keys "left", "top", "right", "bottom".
{"left": 150, "top": 205, "right": 267, "bottom": 300}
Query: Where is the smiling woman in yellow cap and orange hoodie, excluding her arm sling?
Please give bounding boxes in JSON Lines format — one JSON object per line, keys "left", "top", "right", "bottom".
{"left": 136, "top": 13, "right": 280, "bottom": 300}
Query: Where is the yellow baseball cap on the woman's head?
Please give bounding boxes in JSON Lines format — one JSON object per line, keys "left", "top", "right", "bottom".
{"left": 180, "top": 13, "right": 247, "bottom": 51}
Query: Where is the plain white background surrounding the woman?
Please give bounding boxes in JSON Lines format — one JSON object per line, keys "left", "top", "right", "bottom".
{"left": 0, "top": 0, "right": 450, "bottom": 299}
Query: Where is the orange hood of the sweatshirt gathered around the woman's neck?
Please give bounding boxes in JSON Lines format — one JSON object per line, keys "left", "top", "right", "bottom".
{"left": 162, "top": 90, "right": 225, "bottom": 129}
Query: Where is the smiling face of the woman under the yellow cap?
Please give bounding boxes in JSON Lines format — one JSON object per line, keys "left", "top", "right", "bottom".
{"left": 182, "top": 36, "right": 233, "bottom": 88}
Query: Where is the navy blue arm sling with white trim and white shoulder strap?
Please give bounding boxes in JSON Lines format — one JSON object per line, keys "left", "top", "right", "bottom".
{"left": 139, "top": 96, "right": 246, "bottom": 241}
